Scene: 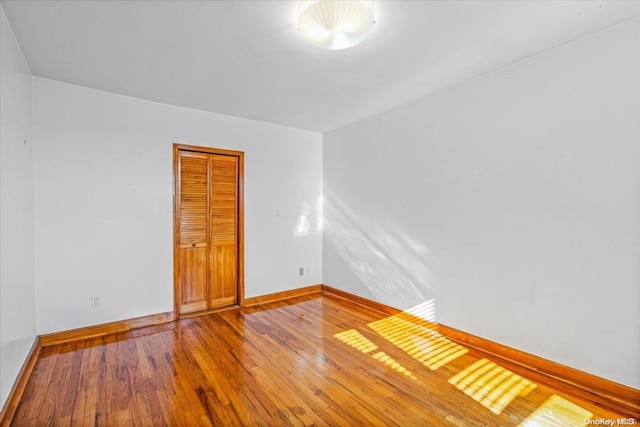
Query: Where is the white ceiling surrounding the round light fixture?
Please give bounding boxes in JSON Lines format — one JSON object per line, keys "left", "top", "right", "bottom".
{"left": 1, "top": 0, "right": 640, "bottom": 132}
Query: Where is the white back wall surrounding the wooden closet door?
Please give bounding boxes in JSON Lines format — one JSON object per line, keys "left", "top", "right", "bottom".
{"left": 34, "top": 78, "right": 322, "bottom": 334}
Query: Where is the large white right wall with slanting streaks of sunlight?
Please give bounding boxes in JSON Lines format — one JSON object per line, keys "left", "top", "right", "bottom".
{"left": 323, "top": 19, "right": 640, "bottom": 388}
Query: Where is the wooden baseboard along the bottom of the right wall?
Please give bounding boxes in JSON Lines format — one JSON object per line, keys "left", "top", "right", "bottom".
{"left": 322, "top": 285, "right": 640, "bottom": 418}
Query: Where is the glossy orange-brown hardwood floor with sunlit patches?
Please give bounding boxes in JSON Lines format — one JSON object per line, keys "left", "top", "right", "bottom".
{"left": 12, "top": 294, "right": 628, "bottom": 427}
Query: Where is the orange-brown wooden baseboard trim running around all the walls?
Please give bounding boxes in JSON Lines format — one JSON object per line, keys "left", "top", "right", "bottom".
{"left": 0, "top": 284, "right": 640, "bottom": 427}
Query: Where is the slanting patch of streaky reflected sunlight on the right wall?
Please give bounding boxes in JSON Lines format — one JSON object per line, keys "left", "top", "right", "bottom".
{"left": 323, "top": 188, "right": 436, "bottom": 314}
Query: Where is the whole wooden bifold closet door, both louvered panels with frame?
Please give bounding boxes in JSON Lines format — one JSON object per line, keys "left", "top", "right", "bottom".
{"left": 174, "top": 144, "right": 244, "bottom": 315}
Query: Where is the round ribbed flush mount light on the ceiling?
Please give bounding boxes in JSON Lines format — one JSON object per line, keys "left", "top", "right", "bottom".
{"left": 298, "top": 0, "right": 375, "bottom": 50}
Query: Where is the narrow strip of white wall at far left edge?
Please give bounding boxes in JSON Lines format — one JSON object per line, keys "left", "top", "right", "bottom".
{"left": 0, "top": 8, "right": 36, "bottom": 406}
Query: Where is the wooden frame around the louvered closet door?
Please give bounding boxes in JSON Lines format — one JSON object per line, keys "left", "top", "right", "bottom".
{"left": 173, "top": 142, "right": 244, "bottom": 319}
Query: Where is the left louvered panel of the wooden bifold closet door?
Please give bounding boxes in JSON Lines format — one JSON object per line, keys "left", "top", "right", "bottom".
{"left": 178, "top": 151, "right": 209, "bottom": 313}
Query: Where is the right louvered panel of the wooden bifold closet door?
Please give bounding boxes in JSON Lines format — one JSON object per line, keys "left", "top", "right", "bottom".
{"left": 209, "top": 154, "right": 238, "bottom": 308}
